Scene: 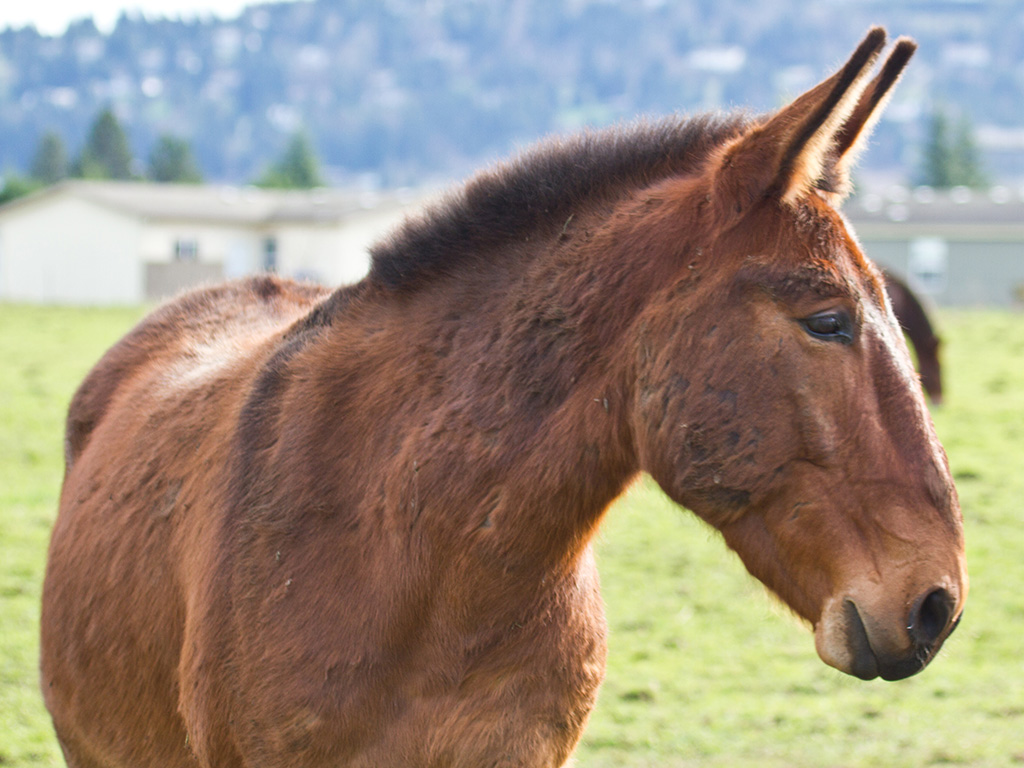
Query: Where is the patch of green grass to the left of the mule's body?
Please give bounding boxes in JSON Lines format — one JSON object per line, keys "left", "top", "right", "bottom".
{"left": 0, "top": 304, "right": 141, "bottom": 768}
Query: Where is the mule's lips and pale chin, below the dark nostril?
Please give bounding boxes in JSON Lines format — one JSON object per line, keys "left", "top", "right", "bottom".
{"left": 814, "top": 598, "right": 941, "bottom": 680}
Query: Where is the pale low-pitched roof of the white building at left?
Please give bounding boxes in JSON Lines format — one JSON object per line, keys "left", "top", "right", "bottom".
{"left": 0, "top": 179, "right": 416, "bottom": 225}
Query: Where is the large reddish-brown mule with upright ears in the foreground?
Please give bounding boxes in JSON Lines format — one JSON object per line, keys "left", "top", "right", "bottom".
{"left": 42, "top": 29, "right": 968, "bottom": 768}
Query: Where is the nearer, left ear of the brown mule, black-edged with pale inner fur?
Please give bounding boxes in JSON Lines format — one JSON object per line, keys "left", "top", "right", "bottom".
{"left": 713, "top": 27, "right": 886, "bottom": 217}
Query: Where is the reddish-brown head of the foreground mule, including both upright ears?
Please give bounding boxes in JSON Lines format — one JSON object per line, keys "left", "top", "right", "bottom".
{"left": 633, "top": 30, "right": 967, "bottom": 679}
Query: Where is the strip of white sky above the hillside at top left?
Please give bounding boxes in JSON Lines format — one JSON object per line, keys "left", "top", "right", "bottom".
{"left": 0, "top": 0, "right": 303, "bottom": 35}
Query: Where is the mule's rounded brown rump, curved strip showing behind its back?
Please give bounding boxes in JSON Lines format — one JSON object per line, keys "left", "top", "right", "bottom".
{"left": 65, "top": 275, "right": 328, "bottom": 469}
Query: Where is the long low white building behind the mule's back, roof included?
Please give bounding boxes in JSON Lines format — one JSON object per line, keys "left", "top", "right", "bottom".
{"left": 0, "top": 180, "right": 423, "bottom": 304}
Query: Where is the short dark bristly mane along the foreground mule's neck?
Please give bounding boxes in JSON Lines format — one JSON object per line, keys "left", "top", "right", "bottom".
{"left": 370, "top": 115, "right": 748, "bottom": 289}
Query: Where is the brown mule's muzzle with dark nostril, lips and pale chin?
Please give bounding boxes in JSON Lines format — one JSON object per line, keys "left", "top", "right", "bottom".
{"left": 818, "top": 588, "right": 959, "bottom": 680}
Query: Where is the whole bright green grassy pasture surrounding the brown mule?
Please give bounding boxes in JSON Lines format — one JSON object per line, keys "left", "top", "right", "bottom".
{"left": 0, "top": 305, "right": 1024, "bottom": 768}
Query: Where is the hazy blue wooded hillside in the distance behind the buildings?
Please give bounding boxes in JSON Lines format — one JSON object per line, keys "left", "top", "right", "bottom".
{"left": 0, "top": 0, "right": 1024, "bottom": 185}
